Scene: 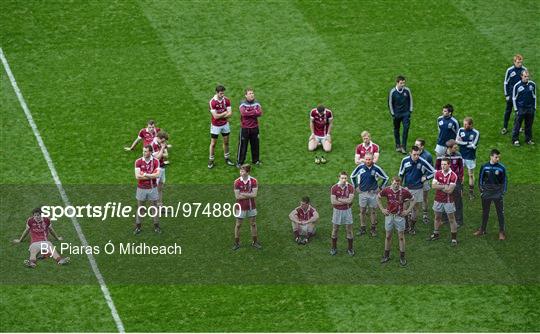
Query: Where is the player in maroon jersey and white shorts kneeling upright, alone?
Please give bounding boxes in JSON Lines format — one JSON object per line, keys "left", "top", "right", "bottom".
{"left": 308, "top": 104, "right": 334, "bottom": 152}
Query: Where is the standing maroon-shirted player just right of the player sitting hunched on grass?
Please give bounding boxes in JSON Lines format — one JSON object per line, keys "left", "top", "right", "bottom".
{"left": 330, "top": 171, "right": 354, "bottom": 256}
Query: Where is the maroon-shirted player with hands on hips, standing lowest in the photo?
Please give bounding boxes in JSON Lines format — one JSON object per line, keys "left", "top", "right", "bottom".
{"left": 377, "top": 176, "right": 415, "bottom": 266}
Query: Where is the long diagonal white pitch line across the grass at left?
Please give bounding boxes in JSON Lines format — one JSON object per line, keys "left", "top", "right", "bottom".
{"left": 0, "top": 47, "right": 125, "bottom": 333}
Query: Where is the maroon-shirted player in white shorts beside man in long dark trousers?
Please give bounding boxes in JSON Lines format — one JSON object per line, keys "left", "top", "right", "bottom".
{"left": 208, "top": 85, "right": 234, "bottom": 168}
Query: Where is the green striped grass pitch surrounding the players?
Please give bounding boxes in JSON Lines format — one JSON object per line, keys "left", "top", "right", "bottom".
{"left": 0, "top": 1, "right": 540, "bottom": 331}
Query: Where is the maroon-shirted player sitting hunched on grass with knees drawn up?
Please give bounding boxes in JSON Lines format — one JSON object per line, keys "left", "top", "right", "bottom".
{"left": 289, "top": 196, "right": 319, "bottom": 245}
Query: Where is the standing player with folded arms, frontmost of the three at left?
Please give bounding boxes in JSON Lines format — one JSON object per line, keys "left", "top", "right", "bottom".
{"left": 133, "top": 145, "right": 161, "bottom": 235}
